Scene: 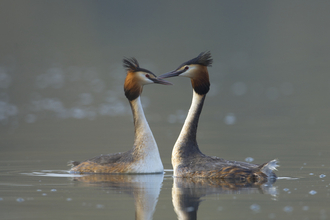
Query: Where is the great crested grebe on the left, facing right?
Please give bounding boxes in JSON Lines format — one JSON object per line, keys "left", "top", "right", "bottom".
{"left": 70, "top": 58, "right": 172, "bottom": 173}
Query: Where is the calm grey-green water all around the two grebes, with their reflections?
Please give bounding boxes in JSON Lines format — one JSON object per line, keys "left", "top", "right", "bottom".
{"left": 0, "top": 1, "right": 330, "bottom": 219}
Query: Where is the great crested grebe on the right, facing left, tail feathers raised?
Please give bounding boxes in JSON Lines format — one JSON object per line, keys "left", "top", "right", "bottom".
{"left": 159, "top": 52, "right": 278, "bottom": 182}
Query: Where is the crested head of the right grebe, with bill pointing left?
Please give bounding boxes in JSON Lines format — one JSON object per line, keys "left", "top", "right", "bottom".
{"left": 159, "top": 51, "right": 213, "bottom": 95}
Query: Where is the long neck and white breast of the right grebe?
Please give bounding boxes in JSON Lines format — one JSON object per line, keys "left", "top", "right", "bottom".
{"left": 172, "top": 91, "right": 205, "bottom": 173}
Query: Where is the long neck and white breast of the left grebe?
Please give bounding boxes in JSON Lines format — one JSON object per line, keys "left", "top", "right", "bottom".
{"left": 130, "top": 96, "right": 164, "bottom": 173}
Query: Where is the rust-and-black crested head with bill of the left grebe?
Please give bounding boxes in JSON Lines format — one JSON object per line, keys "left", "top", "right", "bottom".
{"left": 123, "top": 58, "right": 172, "bottom": 101}
